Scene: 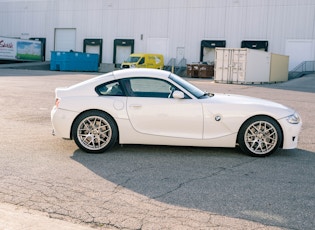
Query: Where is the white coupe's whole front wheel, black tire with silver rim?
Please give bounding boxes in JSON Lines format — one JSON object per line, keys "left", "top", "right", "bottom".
{"left": 237, "top": 116, "right": 283, "bottom": 157}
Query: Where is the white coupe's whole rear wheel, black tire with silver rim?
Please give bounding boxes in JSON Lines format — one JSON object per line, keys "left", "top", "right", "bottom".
{"left": 72, "top": 111, "right": 118, "bottom": 153}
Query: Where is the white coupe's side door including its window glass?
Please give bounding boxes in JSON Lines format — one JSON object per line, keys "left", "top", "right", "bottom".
{"left": 127, "top": 78, "right": 203, "bottom": 139}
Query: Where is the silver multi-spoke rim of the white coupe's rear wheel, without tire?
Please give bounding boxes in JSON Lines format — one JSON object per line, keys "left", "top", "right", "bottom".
{"left": 77, "top": 116, "right": 113, "bottom": 150}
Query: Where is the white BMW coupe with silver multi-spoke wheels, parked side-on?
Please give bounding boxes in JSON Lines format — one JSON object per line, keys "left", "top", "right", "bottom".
{"left": 51, "top": 69, "right": 302, "bottom": 156}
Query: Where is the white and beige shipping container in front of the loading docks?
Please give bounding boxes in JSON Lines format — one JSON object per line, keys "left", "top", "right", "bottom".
{"left": 214, "top": 48, "right": 289, "bottom": 84}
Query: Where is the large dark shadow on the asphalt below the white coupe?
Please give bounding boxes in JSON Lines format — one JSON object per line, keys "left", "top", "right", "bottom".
{"left": 72, "top": 145, "right": 315, "bottom": 229}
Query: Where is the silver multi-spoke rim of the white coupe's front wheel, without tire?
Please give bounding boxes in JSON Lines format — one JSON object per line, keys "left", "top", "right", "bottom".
{"left": 244, "top": 121, "right": 278, "bottom": 155}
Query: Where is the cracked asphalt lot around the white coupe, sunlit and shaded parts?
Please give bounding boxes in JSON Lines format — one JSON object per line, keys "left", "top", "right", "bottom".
{"left": 0, "top": 69, "right": 315, "bottom": 229}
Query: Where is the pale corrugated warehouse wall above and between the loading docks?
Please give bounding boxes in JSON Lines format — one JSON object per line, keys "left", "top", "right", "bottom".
{"left": 0, "top": 0, "right": 315, "bottom": 68}
